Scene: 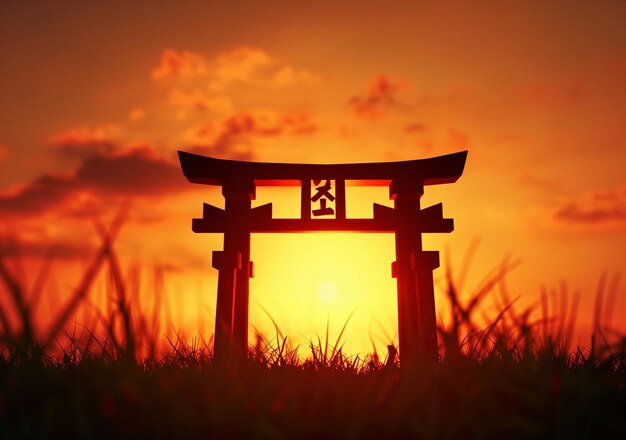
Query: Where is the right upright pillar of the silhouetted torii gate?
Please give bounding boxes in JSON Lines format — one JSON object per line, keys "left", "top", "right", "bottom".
{"left": 389, "top": 179, "right": 438, "bottom": 366}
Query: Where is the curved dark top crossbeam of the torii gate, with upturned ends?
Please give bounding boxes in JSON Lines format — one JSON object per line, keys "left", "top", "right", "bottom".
{"left": 178, "top": 151, "right": 467, "bottom": 186}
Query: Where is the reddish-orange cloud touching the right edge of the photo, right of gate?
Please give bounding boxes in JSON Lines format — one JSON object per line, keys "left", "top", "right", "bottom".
{"left": 554, "top": 184, "right": 626, "bottom": 226}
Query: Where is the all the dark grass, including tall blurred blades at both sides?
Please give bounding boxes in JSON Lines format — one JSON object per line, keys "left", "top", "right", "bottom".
{"left": 0, "top": 216, "right": 626, "bottom": 439}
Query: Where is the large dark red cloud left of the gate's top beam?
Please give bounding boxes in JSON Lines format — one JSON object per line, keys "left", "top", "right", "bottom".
{"left": 0, "top": 141, "right": 189, "bottom": 216}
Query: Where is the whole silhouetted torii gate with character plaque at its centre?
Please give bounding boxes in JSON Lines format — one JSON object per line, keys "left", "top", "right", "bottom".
{"left": 178, "top": 151, "right": 467, "bottom": 365}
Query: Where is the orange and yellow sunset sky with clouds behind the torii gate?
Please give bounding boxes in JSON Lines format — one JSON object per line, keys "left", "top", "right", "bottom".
{"left": 0, "top": 0, "right": 626, "bottom": 351}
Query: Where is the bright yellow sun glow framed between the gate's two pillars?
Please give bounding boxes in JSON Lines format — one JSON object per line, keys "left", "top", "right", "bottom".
{"left": 250, "top": 233, "right": 397, "bottom": 356}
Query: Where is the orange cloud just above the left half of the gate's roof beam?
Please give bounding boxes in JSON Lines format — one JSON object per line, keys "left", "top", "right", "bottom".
{"left": 187, "top": 110, "right": 318, "bottom": 160}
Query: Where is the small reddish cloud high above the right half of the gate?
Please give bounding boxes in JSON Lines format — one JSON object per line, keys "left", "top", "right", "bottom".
{"left": 348, "top": 74, "right": 407, "bottom": 119}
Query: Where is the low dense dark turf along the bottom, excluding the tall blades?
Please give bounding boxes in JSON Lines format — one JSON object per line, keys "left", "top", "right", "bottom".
{"left": 0, "top": 332, "right": 626, "bottom": 439}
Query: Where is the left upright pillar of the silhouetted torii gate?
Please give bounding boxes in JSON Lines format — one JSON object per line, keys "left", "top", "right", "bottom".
{"left": 213, "top": 179, "right": 256, "bottom": 362}
